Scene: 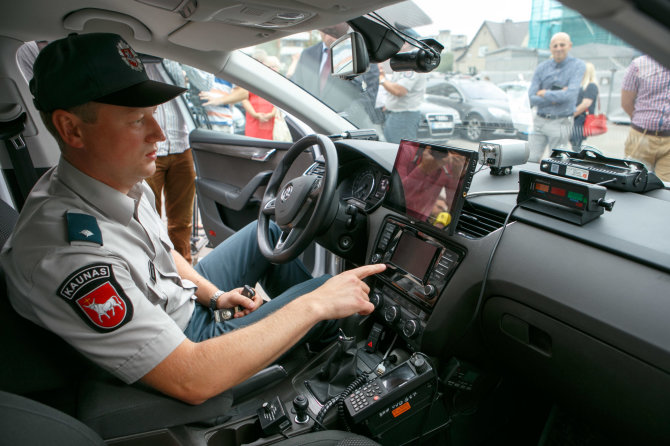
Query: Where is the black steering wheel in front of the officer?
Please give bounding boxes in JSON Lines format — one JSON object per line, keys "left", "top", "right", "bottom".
{"left": 257, "top": 134, "right": 338, "bottom": 263}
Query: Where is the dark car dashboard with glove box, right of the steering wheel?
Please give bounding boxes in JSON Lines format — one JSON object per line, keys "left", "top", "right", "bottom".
{"left": 318, "top": 141, "right": 670, "bottom": 442}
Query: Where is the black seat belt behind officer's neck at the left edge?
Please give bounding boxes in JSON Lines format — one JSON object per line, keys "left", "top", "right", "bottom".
{"left": 0, "top": 104, "right": 38, "bottom": 209}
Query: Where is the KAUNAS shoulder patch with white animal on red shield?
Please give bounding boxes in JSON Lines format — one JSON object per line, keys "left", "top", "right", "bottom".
{"left": 57, "top": 263, "right": 133, "bottom": 333}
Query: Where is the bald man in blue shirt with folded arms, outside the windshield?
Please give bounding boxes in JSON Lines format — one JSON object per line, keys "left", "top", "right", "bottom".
{"left": 528, "top": 32, "right": 585, "bottom": 162}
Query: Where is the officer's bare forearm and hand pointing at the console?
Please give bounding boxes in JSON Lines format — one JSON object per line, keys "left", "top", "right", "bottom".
{"left": 142, "top": 264, "right": 385, "bottom": 404}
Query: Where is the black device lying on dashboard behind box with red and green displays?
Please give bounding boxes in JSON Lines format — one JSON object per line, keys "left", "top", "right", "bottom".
{"left": 540, "top": 149, "right": 664, "bottom": 192}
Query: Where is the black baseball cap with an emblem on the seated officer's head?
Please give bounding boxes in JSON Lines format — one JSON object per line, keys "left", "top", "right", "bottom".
{"left": 30, "top": 33, "right": 186, "bottom": 112}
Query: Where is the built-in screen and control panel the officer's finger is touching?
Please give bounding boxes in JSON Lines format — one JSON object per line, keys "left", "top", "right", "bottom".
{"left": 370, "top": 217, "right": 465, "bottom": 349}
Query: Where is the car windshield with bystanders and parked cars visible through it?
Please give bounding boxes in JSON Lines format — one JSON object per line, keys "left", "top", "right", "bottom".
{"left": 232, "top": 0, "right": 670, "bottom": 180}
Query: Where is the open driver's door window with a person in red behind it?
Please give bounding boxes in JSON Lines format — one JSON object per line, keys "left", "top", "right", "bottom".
{"left": 164, "top": 57, "right": 292, "bottom": 141}
